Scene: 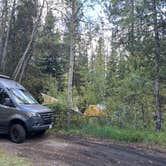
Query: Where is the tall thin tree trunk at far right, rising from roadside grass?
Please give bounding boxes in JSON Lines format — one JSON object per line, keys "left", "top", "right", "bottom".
{"left": 152, "top": 0, "right": 161, "bottom": 131}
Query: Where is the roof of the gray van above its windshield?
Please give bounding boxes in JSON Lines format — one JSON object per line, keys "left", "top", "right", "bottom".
{"left": 0, "top": 77, "right": 25, "bottom": 89}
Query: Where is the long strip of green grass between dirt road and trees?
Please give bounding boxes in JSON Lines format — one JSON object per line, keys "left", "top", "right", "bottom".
{"left": 55, "top": 124, "right": 166, "bottom": 147}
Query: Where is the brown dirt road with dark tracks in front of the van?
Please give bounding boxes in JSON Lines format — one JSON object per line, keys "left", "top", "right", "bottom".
{"left": 0, "top": 134, "right": 166, "bottom": 166}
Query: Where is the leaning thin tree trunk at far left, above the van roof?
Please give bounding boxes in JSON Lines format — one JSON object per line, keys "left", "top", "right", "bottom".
{"left": 1, "top": 0, "right": 16, "bottom": 72}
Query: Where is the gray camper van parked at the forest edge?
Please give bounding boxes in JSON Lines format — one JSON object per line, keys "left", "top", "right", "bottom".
{"left": 0, "top": 75, "right": 54, "bottom": 143}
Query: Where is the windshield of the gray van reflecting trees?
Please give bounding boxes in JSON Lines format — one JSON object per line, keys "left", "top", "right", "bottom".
{"left": 10, "top": 88, "right": 38, "bottom": 104}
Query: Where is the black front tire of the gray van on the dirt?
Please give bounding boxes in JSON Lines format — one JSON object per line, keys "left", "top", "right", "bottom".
{"left": 10, "top": 124, "right": 26, "bottom": 143}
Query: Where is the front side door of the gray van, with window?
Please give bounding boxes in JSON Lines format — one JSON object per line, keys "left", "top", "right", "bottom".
{"left": 0, "top": 88, "right": 16, "bottom": 133}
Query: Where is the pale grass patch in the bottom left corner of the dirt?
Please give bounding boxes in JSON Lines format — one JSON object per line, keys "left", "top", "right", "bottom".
{"left": 0, "top": 151, "right": 30, "bottom": 166}
